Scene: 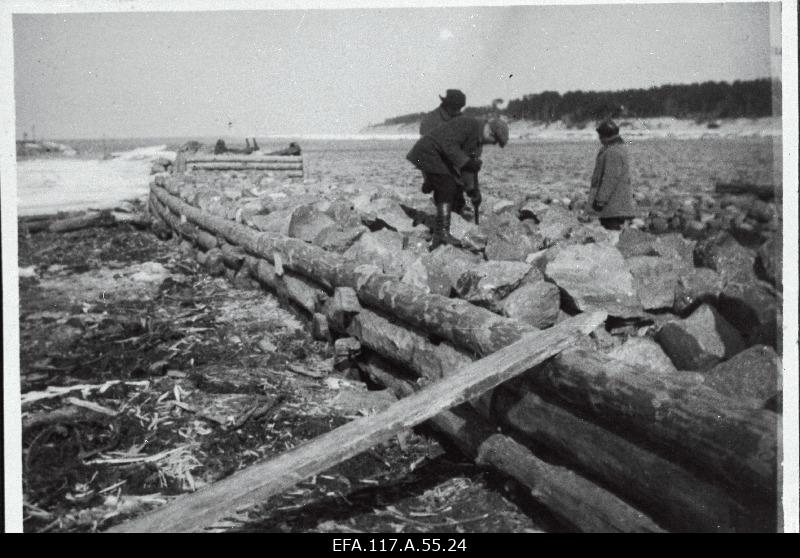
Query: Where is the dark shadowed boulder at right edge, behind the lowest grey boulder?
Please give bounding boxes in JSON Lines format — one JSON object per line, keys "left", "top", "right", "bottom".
{"left": 717, "top": 282, "right": 779, "bottom": 347}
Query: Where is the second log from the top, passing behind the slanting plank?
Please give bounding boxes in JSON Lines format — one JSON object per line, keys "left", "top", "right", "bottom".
{"left": 348, "top": 308, "right": 758, "bottom": 532}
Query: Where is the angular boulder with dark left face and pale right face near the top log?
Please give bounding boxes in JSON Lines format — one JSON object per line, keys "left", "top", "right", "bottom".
{"left": 656, "top": 304, "right": 745, "bottom": 370}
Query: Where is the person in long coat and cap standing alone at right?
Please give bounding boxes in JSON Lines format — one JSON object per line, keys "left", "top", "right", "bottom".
{"left": 589, "top": 120, "right": 635, "bottom": 230}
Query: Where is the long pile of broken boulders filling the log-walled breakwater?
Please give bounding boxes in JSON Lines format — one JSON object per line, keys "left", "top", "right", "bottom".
{"left": 156, "top": 166, "right": 781, "bottom": 416}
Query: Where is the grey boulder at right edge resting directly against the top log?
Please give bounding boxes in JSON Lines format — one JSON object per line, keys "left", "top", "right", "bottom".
{"left": 705, "top": 345, "right": 782, "bottom": 408}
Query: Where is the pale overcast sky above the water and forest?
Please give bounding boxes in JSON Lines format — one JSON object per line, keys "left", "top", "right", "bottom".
{"left": 12, "top": 3, "right": 770, "bottom": 139}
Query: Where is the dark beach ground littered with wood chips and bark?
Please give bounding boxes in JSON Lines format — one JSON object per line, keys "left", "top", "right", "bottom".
{"left": 19, "top": 214, "right": 559, "bottom": 533}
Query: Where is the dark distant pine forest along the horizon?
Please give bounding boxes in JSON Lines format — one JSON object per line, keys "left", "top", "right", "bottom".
{"left": 382, "top": 78, "right": 780, "bottom": 126}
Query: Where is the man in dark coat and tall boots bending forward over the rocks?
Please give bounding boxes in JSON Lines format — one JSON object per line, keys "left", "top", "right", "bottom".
{"left": 406, "top": 116, "right": 508, "bottom": 249}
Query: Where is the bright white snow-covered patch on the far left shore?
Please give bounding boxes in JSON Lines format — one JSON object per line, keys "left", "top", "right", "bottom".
{"left": 17, "top": 145, "right": 175, "bottom": 215}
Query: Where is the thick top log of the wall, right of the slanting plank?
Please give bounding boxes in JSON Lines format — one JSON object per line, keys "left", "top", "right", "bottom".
{"left": 530, "top": 350, "right": 779, "bottom": 499}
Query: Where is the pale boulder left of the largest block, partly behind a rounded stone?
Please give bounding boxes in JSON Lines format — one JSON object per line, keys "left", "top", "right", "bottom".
{"left": 456, "top": 261, "right": 542, "bottom": 313}
